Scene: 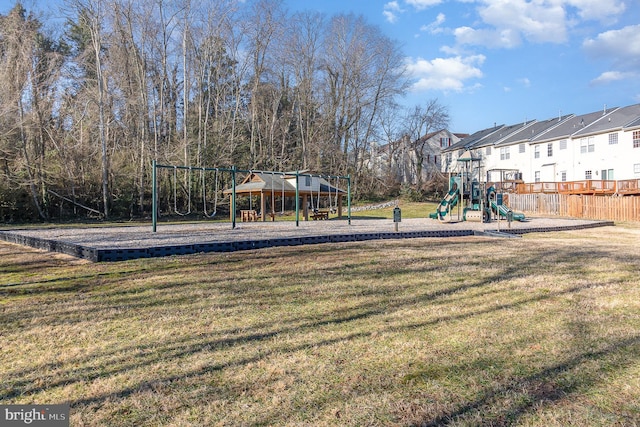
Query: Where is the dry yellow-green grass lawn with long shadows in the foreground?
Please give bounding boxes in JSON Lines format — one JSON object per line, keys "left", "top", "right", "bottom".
{"left": 0, "top": 222, "right": 640, "bottom": 426}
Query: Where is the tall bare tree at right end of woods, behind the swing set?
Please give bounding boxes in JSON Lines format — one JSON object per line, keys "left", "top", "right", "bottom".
{"left": 323, "top": 15, "right": 406, "bottom": 192}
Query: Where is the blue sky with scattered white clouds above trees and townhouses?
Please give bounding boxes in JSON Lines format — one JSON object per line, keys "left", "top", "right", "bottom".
{"left": 5, "top": 0, "right": 640, "bottom": 133}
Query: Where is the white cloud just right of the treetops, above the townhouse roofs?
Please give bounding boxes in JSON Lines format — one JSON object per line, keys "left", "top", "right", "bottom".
{"left": 407, "top": 55, "right": 486, "bottom": 92}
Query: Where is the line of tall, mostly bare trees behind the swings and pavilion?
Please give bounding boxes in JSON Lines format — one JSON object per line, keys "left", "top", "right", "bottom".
{"left": 0, "top": 0, "right": 448, "bottom": 221}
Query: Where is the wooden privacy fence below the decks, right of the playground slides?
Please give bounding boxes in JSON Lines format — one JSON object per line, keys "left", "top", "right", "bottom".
{"left": 508, "top": 193, "right": 640, "bottom": 221}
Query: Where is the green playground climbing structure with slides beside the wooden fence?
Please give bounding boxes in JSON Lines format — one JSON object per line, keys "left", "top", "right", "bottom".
{"left": 429, "top": 150, "right": 525, "bottom": 222}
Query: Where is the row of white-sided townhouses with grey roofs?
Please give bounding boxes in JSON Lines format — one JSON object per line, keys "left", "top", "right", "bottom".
{"left": 442, "top": 104, "right": 640, "bottom": 183}
